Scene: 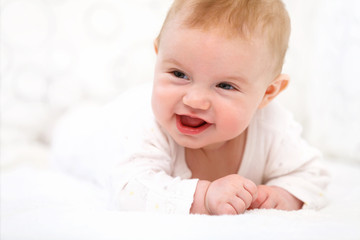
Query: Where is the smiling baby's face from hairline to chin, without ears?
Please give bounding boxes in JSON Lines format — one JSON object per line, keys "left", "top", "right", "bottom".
{"left": 152, "top": 23, "right": 271, "bottom": 148}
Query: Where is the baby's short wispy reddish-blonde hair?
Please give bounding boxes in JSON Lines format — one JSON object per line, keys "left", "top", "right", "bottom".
{"left": 156, "top": 0, "right": 291, "bottom": 74}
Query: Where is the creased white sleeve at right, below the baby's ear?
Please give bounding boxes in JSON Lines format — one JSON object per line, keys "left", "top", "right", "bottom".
{"left": 263, "top": 109, "right": 330, "bottom": 209}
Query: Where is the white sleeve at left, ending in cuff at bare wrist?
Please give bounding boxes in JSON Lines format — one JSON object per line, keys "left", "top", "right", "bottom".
{"left": 111, "top": 124, "right": 198, "bottom": 214}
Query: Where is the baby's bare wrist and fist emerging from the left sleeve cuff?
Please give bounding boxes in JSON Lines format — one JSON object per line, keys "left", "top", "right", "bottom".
{"left": 190, "top": 174, "right": 257, "bottom": 215}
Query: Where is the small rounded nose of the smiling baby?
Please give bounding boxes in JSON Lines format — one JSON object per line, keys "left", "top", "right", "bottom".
{"left": 183, "top": 90, "right": 211, "bottom": 110}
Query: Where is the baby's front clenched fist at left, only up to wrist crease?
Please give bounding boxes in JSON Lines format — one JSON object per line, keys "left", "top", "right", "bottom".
{"left": 205, "top": 174, "right": 257, "bottom": 215}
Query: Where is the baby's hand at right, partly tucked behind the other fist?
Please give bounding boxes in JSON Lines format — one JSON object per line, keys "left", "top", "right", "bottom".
{"left": 250, "top": 185, "right": 303, "bottom": 211}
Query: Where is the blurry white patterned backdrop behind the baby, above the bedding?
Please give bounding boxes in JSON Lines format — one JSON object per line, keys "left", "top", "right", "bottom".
{"left": 0, "top": 0, "right": 360, "bottom": 166}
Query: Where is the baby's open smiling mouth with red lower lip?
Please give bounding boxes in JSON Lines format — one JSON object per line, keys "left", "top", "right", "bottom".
{"left": 176, "top": 115, "right": 211, "bottom": 135}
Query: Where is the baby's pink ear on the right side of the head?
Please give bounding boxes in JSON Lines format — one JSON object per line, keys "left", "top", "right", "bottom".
{"left": 259, "top": 74, "right": 290, "bottom": 108}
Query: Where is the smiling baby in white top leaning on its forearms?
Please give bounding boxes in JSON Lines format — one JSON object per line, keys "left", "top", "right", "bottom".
{"left": 114, "top": 0, "right": 328, "bottom": 215}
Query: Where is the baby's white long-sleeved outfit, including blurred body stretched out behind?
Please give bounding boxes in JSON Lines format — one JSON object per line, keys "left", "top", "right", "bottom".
{"left": 53, "top": 85, "right": 328, "bottom": 213}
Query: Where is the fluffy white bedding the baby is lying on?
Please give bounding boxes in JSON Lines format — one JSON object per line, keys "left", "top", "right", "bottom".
{"left": 0, "top": 160, "right": 360, "bottom": 240}
